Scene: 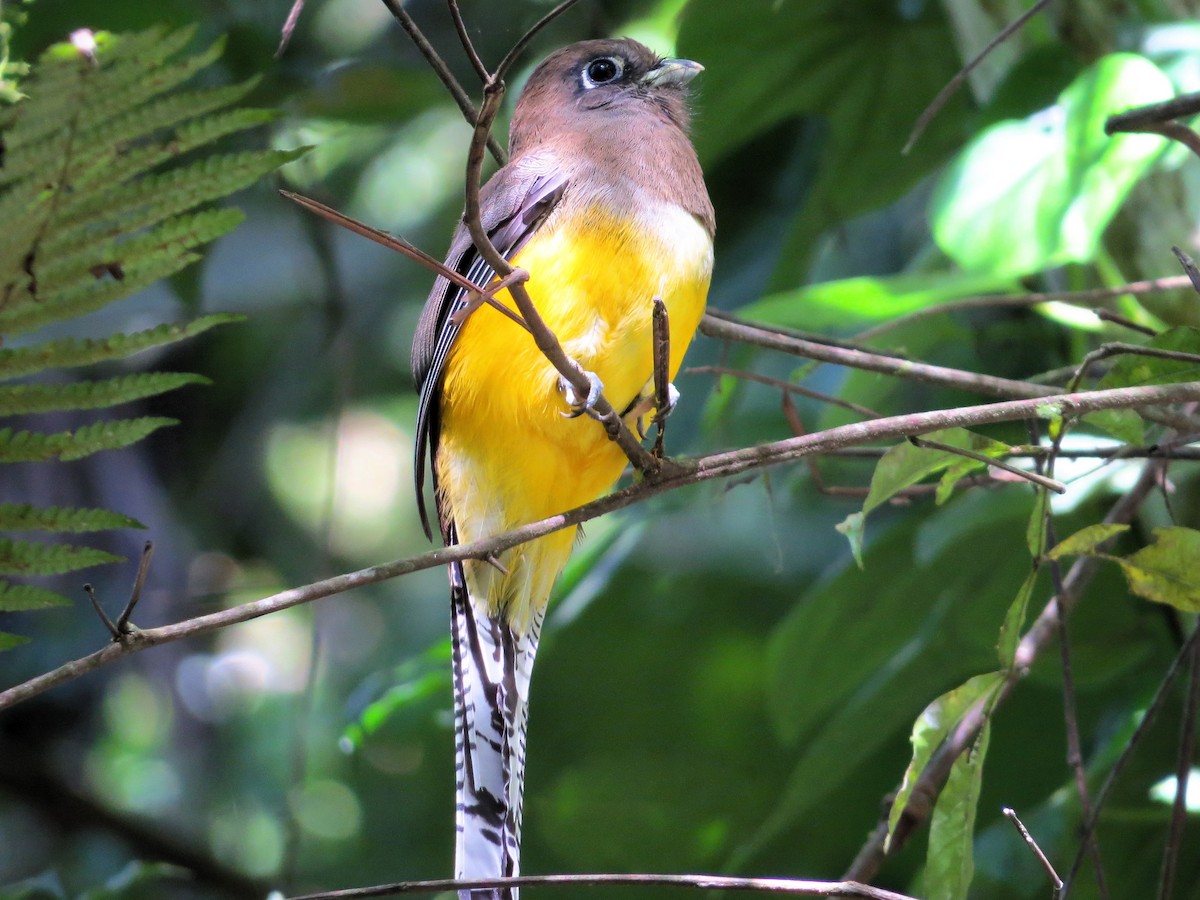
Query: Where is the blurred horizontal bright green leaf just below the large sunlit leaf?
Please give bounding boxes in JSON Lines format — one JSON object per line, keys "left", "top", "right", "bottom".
{"left": 738, "top": 271, "right": 1020, "bottom": 330}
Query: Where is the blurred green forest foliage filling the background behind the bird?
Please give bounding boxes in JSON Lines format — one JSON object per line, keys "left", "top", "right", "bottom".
{"left": 0, "top": 0, "right": 1200, "bottom": 900}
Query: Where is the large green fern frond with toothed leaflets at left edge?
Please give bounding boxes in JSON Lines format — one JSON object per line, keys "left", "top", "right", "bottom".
{"left": 0, "top": 22, "right": 305, "bottom": 649}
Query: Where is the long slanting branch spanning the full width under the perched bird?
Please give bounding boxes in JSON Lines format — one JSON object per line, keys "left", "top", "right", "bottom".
{"left": 7, "top": 382, "right": 1200, "bottom": 709}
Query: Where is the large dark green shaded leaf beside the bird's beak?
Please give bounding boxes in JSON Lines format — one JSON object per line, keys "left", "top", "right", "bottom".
{"left": 678, "top": 0, "right": 967, "bottom": 283}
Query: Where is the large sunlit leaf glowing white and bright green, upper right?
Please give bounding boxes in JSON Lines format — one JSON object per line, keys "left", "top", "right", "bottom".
{"left": 931, "top": 53, "right": 1174, "bottom": 276}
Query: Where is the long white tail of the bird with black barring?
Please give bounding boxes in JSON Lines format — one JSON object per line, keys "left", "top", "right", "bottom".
{"left": 450, "top": 584, "right": 542, "bottom": 900}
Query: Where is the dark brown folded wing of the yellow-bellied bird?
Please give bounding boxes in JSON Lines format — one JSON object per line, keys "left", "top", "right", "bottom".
{"left": 412, "top": 160, "right": 568, "bottom": 544}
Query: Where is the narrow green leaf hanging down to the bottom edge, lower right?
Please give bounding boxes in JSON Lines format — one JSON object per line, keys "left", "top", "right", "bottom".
{"left": 925, "top": 720, "right": 991, "bottom": 900}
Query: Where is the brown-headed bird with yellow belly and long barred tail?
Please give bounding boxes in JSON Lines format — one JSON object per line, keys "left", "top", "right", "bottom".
{"left": 412, "top": 38, "right": 715, "bottom": 900}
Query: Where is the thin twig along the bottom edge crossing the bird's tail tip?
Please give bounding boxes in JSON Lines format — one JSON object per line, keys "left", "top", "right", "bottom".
{"left": 290, "top": 875, "right": 914, "bottom": 900}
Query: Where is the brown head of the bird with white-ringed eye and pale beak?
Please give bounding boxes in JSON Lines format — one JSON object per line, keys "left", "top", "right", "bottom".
{"left": 509, "top": 37, "right": 703, "bottom": 158}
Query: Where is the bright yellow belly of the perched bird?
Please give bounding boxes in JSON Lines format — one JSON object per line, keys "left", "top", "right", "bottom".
{"left": 437, "top": 206, "right": 713, "bottom": 630}
